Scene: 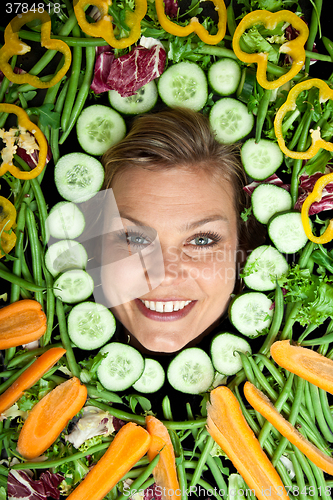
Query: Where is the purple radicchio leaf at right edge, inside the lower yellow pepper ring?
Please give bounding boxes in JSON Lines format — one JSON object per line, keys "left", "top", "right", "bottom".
{"left": 294, "top": 169, "right": 333, "bottom": 215}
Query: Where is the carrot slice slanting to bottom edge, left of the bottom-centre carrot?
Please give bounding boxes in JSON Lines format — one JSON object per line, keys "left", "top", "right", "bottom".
{"left": 67, "top": 422, "right": 150, "bottom": 500}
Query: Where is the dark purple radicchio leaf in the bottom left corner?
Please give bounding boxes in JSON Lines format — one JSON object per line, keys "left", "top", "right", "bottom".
{"left": 7, "top": 469, "right": 64, "bottom": 500}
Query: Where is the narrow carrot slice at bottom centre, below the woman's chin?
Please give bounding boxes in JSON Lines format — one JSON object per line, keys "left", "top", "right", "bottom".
{"left": 146, "top": 415, "right": 181, "bottom": 500}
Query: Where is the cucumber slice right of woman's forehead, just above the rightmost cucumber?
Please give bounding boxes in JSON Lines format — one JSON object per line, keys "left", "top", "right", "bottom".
{"left": 251, "top": 184, "right": 293, "bottom": 224}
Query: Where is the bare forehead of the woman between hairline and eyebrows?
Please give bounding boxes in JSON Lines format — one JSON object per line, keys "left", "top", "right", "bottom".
{"left": 111, "top": 168, "right": 237, "bottom": 222}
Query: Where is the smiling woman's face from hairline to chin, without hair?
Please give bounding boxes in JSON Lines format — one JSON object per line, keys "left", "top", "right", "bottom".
{"left": 102, "top": 168, "right": 237, "bottom": 353}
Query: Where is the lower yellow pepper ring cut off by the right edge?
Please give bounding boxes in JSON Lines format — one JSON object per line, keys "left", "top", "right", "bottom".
{"left": 301, "top": 173, "right": 333, "bottom": 244}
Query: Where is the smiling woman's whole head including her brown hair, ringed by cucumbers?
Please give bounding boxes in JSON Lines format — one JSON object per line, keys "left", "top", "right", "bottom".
{"left": 101, "top": 108, "right": 253, "bottom": 353}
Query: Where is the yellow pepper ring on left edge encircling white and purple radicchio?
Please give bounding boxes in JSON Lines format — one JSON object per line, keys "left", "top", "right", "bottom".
{"left": 0, "top": 103, "right": 48, "bottom": 180}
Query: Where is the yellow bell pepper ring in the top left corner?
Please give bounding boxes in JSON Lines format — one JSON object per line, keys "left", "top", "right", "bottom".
{"left": 0, "top": 10, "right": 72, "bottom": 89}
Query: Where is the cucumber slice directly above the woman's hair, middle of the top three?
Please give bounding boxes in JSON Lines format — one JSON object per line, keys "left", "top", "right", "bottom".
{"left": 158, "top": 61, "right": 208, "bottom": 111}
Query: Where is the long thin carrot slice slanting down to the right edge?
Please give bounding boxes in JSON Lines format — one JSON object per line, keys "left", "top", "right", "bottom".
{"left": 244, "top": 382, "right": 333, "bottom": 474}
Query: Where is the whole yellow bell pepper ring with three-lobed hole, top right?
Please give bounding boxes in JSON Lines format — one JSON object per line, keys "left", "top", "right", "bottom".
{"left": 232, "top": 10, "right": 309, "bottom": 89}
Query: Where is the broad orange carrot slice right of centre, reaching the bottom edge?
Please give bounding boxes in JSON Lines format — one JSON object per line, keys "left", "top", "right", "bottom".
{"left": 207, "top": 386, "right": 289, "bottom": 500}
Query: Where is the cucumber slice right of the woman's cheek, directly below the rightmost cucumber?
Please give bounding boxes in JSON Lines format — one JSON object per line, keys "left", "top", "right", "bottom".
{"left": 243, "top": 245, "right": 289, "bottom": 292}
